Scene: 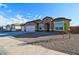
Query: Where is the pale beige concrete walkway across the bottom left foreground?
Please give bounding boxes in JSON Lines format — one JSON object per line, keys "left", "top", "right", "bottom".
{"left": 0, "top": 37, "right": 67, "bottom": 55}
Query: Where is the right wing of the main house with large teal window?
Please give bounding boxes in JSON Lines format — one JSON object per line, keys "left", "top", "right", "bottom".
{"left": 53, "top": 17, "right": 71, "bottom": 32}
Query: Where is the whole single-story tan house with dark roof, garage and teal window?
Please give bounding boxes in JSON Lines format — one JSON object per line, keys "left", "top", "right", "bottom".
{"left": 21, "top": 16, "right": 71, "bottom": 32}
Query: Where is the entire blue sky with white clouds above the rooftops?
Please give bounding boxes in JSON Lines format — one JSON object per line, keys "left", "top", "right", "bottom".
{"left": 0, "top": 3, "right": 79, "bottom": 25}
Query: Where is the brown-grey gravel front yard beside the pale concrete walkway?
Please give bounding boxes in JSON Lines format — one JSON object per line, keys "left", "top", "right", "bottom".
{"left": 11, "top": 33, "right": 79, "bottom": 54}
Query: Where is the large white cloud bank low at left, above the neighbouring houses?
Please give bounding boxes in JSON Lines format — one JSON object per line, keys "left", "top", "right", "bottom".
{"left": 0, "top": 15, "right": 28, "bottom": 26}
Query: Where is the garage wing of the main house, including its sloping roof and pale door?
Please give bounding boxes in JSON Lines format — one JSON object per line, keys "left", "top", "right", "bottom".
{"left": 24, "top": 19, "right": 41, "bottom": 32}
